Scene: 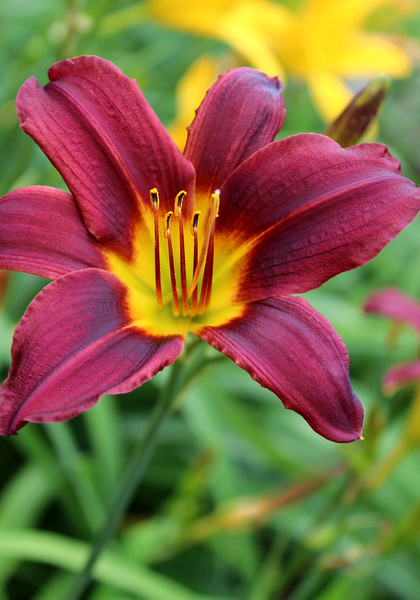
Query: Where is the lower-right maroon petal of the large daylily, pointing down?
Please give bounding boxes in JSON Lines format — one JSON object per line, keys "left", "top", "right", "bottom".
{"left": 198, "top": 298, "right": 363, "bottom": 442}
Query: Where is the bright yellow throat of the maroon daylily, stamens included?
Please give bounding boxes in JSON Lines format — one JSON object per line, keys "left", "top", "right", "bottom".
{"left": 107, "top": 188, "right": 243, "bottom": 337}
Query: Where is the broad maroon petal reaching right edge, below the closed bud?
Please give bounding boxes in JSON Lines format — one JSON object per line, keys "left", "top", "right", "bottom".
{"left": 217, "top": 134, "right": 420, "bottom": 302}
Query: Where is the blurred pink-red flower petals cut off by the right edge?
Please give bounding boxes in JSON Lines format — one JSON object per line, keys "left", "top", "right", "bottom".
{"left": 364, "top": 287, "right": 420, "bottom": 394}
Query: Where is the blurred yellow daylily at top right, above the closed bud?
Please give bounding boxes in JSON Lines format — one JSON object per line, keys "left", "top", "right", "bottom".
{"left": 276, "top": 0, "right": 411, "bottom": 121}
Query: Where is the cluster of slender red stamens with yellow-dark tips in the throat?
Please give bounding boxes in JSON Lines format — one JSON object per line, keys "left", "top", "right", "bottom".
{"left": 150, "top": 188, "right": 220, "bottom": 317}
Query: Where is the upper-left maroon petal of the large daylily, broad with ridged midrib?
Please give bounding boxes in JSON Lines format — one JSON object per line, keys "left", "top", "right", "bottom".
{"left": 17, "top": 56, "right": 194, "bottom": 258}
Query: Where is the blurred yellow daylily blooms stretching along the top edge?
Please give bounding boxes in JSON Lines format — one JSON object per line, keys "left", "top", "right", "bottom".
{"left": 148, "top": 0, "right": 418, "bottom": 122}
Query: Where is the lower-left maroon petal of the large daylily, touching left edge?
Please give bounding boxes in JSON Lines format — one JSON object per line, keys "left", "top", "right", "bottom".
{"left": 0, "top": 269, "right": 183, "bottom": 435}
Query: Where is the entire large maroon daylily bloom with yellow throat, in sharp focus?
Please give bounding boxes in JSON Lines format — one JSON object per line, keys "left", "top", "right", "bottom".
{"left": 0, "top": 57, "right": 420, "bottom": 442}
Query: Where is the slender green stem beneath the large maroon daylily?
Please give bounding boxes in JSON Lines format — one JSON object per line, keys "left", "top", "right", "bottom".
{"left": 67, "top": 358, "right": 184, "bottom": 600}
